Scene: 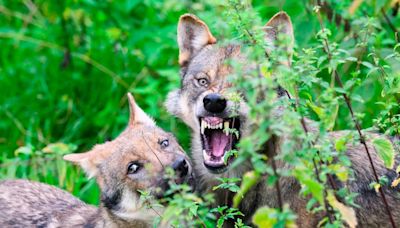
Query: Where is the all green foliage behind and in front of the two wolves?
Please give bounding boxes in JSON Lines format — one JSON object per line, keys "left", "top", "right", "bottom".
{"left": 0, "top": 0, "right": 400, "bottom": 227}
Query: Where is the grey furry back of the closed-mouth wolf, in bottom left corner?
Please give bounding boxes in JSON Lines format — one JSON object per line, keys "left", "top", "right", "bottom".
{"left": 0, "top": 180, "right": 97, "bottom": 227}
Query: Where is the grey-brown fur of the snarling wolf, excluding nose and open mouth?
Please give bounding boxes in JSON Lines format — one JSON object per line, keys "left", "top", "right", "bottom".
{"left": 165, "top": 12, "right": 400, "bottom": 227}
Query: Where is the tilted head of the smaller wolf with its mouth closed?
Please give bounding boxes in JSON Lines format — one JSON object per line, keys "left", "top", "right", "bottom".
{"left": 64, "top": 94, "right": 193, "bottom": 220}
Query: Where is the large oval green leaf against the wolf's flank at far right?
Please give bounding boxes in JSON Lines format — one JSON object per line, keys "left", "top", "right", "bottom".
{"left": 372, "top": 137, "right": 395, "bottom": 169}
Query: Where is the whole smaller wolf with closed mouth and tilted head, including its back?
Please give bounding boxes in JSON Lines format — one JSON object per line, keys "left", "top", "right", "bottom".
{"left": 0, "top": 94, "right": 193, "bottom": 228}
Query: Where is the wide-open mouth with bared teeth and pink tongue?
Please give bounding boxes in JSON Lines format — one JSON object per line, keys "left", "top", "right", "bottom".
{"left": 200, "top": 116, "right": 240, "bottom": 173}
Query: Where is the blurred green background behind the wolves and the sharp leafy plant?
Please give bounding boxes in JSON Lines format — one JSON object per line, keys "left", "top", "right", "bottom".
{"left": 0, "top": 0, "right": 400, "bottom": 204}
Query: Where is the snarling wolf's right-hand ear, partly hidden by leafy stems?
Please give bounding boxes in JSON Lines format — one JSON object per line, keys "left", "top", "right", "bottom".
{"left": 265, "top": 11, "right": 294, "bottom": 66}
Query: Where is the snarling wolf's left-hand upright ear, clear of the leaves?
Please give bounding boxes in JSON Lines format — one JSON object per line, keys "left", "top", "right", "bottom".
{"left": 178, "top": 14, "right": 217, "bottom": 67}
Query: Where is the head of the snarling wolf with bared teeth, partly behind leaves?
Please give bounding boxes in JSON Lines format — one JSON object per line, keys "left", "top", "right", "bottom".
{"left": 166, "top": 12, "right": 293, "bottom": 175}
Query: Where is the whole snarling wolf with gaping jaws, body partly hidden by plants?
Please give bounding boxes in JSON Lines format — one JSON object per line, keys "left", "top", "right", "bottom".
{"left": 165, "top": 12, "right": 400, "bottom": 227}
